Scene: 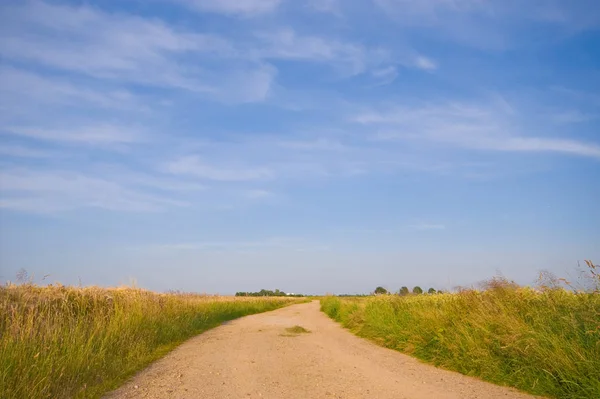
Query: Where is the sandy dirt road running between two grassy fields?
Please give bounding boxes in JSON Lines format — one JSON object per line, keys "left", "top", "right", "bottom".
{"left": 107, "top": 301, "right": 532, "bottom": 399}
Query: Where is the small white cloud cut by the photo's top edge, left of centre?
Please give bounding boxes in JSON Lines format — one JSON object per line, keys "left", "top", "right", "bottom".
{"left": 176, "top": 0, "right": 281, "bottom": 17}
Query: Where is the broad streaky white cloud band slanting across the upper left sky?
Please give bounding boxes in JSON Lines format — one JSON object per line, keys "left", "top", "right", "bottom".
{"left": 0, "top": 2, "right": 276, "bottom": 102}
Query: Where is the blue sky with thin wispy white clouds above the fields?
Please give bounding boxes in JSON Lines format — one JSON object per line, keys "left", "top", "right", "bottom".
{"left": 0, "top": 0, "right": 600, "bottom": 294}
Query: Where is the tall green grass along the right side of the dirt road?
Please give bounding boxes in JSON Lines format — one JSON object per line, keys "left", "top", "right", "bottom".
{"left": 321, "top": 284, "right": 600, "bottom": 399}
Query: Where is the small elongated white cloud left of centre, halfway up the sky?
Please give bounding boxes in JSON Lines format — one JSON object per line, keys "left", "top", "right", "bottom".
{"left": 165, "top": 155, "right": 274, "bottom": 182}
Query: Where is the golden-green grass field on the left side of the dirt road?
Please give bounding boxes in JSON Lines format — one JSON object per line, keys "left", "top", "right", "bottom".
{"left": 0, "top": 285, "right": 298, "bottom": 399}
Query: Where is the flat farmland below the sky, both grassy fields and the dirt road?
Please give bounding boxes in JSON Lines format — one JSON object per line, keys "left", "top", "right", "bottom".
{"left": 0, "top": 263, "right": 600, "bottom": 399}
